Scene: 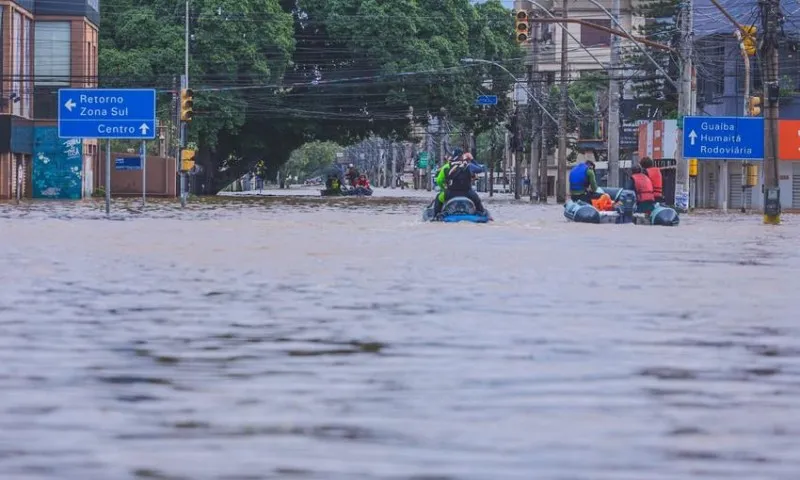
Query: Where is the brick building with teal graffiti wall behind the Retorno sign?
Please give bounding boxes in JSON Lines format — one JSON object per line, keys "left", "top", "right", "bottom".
{"left": 0, "top": 0, "right": 100, "bottom": 199}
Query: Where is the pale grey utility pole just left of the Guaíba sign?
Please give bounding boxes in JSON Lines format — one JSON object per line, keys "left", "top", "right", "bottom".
{"left": 675, "top": 0, "right": 694, "bottom": 211}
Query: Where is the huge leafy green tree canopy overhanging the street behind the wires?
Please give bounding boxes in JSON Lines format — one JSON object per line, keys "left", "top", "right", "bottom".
{"left": 100, "top": 0, "right": 518, "bottom": 193}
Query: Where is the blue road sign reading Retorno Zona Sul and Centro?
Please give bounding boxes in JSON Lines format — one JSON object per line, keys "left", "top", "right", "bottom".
{"left": 58, "top": 88, "right": 156, "bottom": 140}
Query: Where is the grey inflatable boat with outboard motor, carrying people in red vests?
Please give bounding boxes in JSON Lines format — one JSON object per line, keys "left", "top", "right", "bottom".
{"left": 564, "top": 187, "right": 680, "bottom": 227}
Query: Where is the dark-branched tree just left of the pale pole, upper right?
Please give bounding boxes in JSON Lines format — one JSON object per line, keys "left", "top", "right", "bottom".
{"left": 624, "top": 0, "right": 681, "bottom": 120}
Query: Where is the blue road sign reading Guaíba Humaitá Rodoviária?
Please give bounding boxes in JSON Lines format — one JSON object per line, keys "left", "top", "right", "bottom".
{"left": 683, "top": 117, "right": 764, "bottom": 160}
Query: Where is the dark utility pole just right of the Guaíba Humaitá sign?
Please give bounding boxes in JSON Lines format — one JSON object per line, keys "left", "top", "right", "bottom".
{"left": 758, "top": 0, "right": 782, "bottom": 225}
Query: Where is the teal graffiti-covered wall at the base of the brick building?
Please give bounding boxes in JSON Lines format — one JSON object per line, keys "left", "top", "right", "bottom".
{"left": 31, "top": 127, "right": 83, "bottom": 200}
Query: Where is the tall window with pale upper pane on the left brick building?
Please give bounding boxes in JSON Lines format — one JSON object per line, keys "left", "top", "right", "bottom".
{"left": 33, "top": 22, "right": 71, "bottom": 119}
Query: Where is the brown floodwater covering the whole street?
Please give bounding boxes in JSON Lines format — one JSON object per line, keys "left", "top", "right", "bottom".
{"left": 0, "top": 190, "right": 800, "bottom": 480}
